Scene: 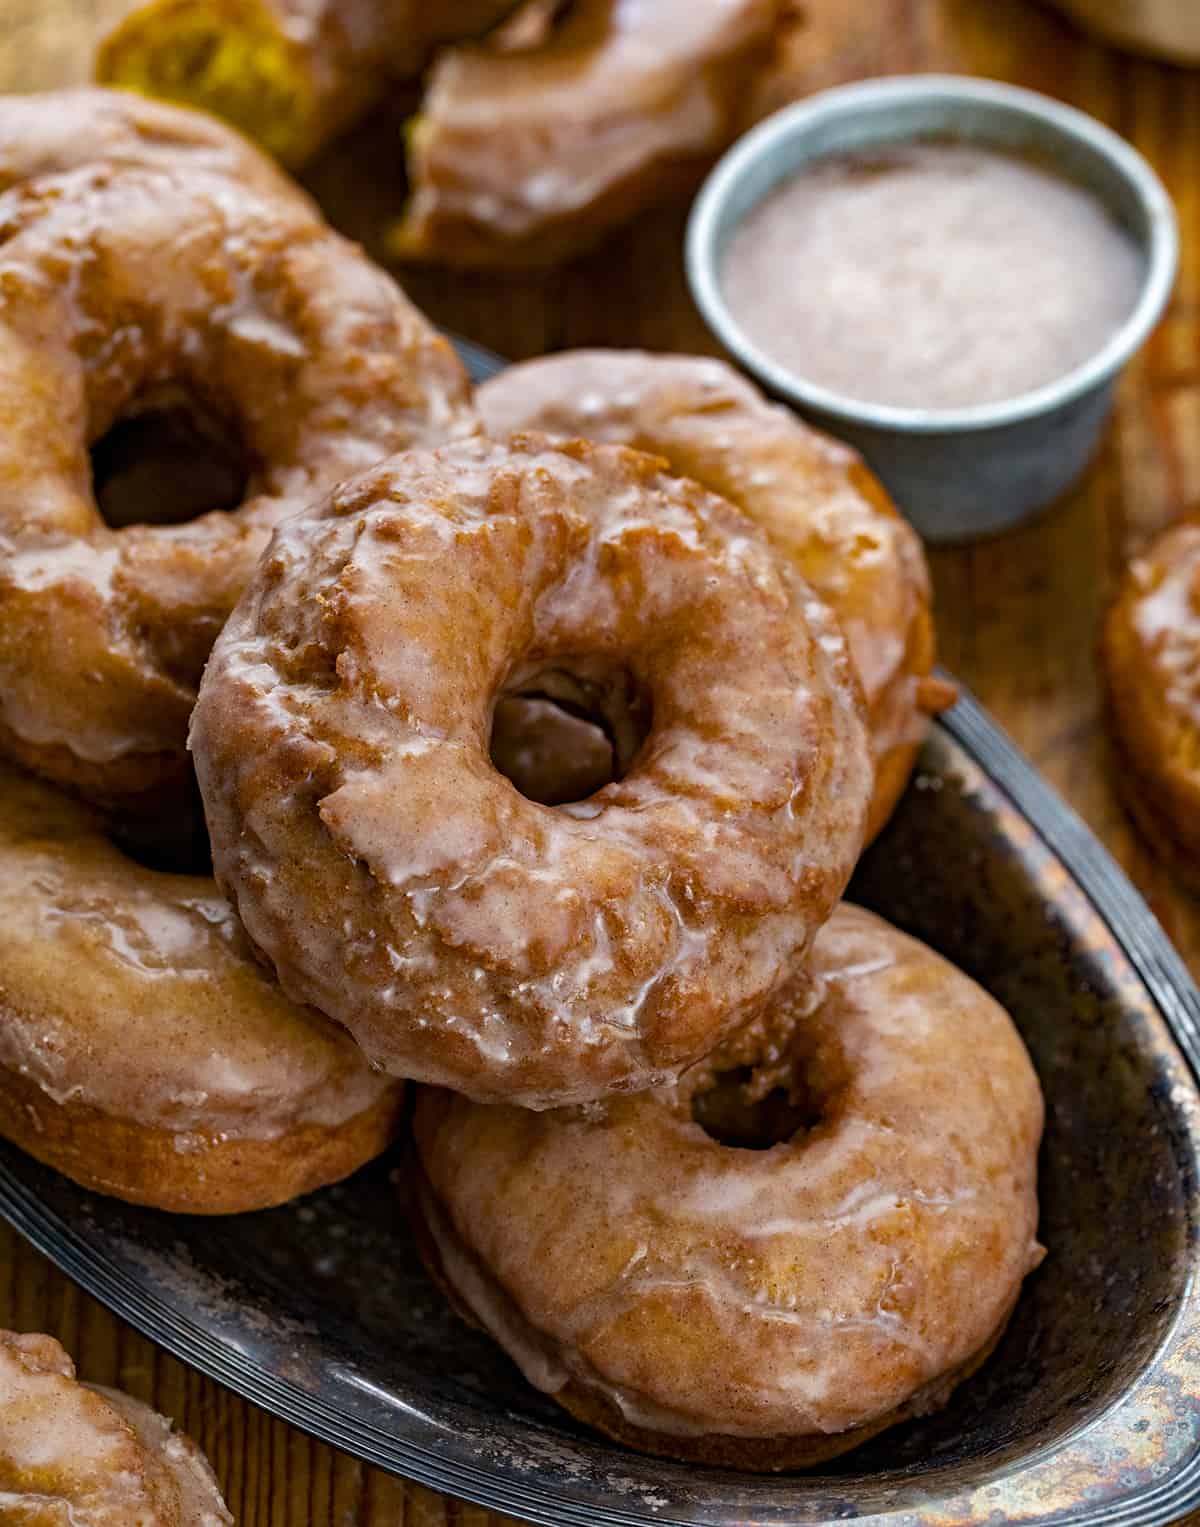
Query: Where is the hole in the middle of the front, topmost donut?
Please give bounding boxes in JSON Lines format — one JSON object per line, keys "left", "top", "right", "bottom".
{"left": 490, "top": 660, "right": 652, "bottom": 806}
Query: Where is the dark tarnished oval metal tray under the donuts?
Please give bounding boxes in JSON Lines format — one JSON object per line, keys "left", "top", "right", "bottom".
{"left": 0, "top": 340, "right": 1200, "bottom": 1527}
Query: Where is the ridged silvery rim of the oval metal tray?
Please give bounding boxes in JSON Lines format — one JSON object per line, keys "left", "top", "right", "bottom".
{"left": 0, "top": 336, "right": 1200, "bottom": 1527}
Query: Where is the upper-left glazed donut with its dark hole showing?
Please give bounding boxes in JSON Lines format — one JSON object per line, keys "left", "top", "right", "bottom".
{"left": 0, "top": 168, "right": 476, "bottom": 805}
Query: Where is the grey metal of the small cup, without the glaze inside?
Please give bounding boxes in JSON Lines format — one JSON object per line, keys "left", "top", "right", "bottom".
{"left": 687, "top": 75, "right": 1179, "bottom": 541}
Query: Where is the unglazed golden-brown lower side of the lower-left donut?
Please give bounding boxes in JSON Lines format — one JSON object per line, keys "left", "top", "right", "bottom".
{"left": 0, "top": 1056, "right": 403, "bottom": 1214}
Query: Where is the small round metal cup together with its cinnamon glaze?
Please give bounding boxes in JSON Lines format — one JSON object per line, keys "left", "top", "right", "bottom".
{"left": 687, "top": 75, "right": 1179, "bottom": 541}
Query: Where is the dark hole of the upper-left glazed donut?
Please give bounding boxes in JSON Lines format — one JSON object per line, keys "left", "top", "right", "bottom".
{"left": 90, "top": 388, "right": 250, "bottom": 530}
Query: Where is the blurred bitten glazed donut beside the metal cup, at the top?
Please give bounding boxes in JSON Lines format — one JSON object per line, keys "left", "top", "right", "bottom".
{"left": 391, "top": 0, "right": 779, "bottom": 266}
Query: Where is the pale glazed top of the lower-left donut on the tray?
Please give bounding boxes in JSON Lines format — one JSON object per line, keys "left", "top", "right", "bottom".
{"left": 0, "top": 770, "right": 392, "bottom": 1151}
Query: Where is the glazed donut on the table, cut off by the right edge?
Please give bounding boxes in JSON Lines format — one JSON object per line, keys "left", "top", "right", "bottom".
{"left": 1101, "top": 510, "right": 1200, "bottom": 890}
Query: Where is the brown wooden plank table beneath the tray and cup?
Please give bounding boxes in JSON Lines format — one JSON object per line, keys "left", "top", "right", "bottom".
{"left": 0, "top": 0, "right": 1200, "bottom": 1527}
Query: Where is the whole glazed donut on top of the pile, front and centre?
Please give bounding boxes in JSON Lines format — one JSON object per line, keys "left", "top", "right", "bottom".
{"left": 191, "top": 435, "right": 870, "bottom": 1109}
